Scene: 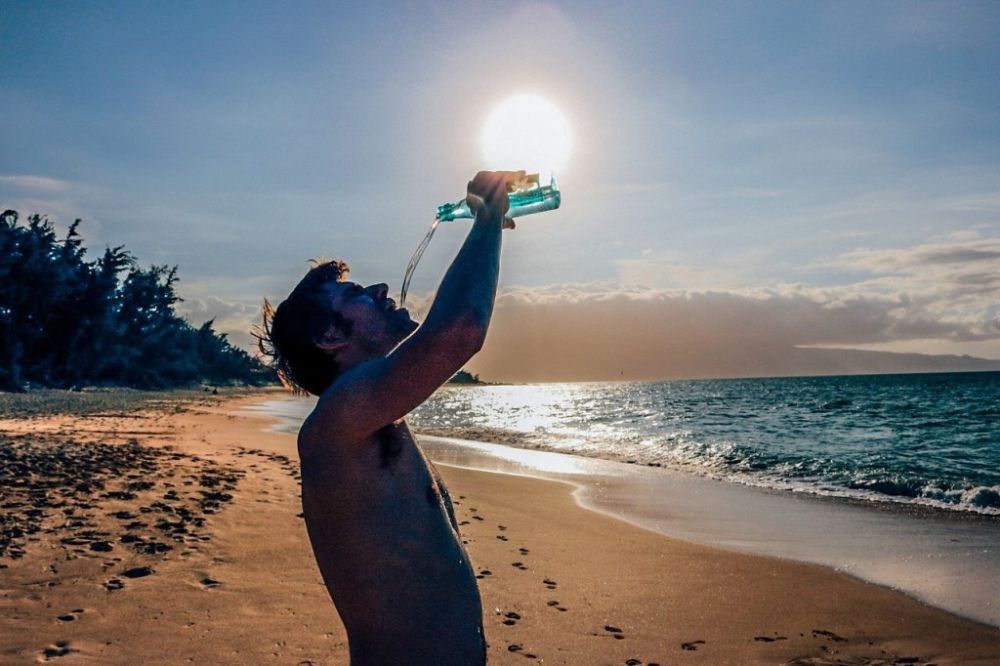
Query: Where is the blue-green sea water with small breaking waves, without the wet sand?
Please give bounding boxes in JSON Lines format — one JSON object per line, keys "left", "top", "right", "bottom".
{"left": 409, "top": 372, "right": 1000, "bottom": 515}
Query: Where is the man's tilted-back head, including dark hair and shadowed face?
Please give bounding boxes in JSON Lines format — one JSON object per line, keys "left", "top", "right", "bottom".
{"left": 260, "top": 260, "right": 417, "bottom": 395}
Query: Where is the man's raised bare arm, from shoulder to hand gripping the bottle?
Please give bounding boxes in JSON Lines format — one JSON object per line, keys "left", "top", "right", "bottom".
{"left": 304, "top": 171, "right": 517, "bottom": 441}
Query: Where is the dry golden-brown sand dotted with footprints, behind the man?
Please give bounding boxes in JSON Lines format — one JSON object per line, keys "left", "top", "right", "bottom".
{"left": 0, "top": 394, "right": 1000, "bottom": 664}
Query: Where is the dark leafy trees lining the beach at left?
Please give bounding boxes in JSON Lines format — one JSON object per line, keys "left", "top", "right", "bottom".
{"left": 0, "top": 210, "right": 276, "bottom": 391}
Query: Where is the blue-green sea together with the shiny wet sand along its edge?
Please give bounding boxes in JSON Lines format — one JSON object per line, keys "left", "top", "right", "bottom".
{"left": 252, "top": 373, "right": 1000, "bottom": 626}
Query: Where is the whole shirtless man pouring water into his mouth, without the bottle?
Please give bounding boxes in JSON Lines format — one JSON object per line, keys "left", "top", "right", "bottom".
{"left": 263, "top": 172, "right": 518, "bottom": 666}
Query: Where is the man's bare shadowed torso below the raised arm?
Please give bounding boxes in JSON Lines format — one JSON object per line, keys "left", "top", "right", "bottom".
{"left": 300, "top": 421, "right": 485, "bottom": 664}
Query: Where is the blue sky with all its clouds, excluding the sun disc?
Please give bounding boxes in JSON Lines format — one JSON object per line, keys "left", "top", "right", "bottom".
{"left": 0, "top": 0, "right": 1000, "bottom": 381}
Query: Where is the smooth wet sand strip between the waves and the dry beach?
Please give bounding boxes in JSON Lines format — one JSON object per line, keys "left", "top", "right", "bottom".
{"left": 242, "top": 400, "right": 1000, "bottom": 627}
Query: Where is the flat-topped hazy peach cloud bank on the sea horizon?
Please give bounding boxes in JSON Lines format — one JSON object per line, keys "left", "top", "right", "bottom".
{"left": 470, "top": 285, "right": 1000, "bottom": 381}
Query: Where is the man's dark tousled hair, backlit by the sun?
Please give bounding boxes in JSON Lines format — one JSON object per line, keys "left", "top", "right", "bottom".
{"left": 256, "top": 259, "right": 350, "bottom": 395}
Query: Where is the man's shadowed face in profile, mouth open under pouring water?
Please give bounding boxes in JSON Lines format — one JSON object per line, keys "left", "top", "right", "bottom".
{"left": 324, "top": 282, "right": 418, "bottom": 364}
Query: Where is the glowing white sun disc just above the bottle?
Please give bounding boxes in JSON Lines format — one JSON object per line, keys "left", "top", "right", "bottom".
{"left": 482, "top": 95, "right": 571, "bottom": 177}
